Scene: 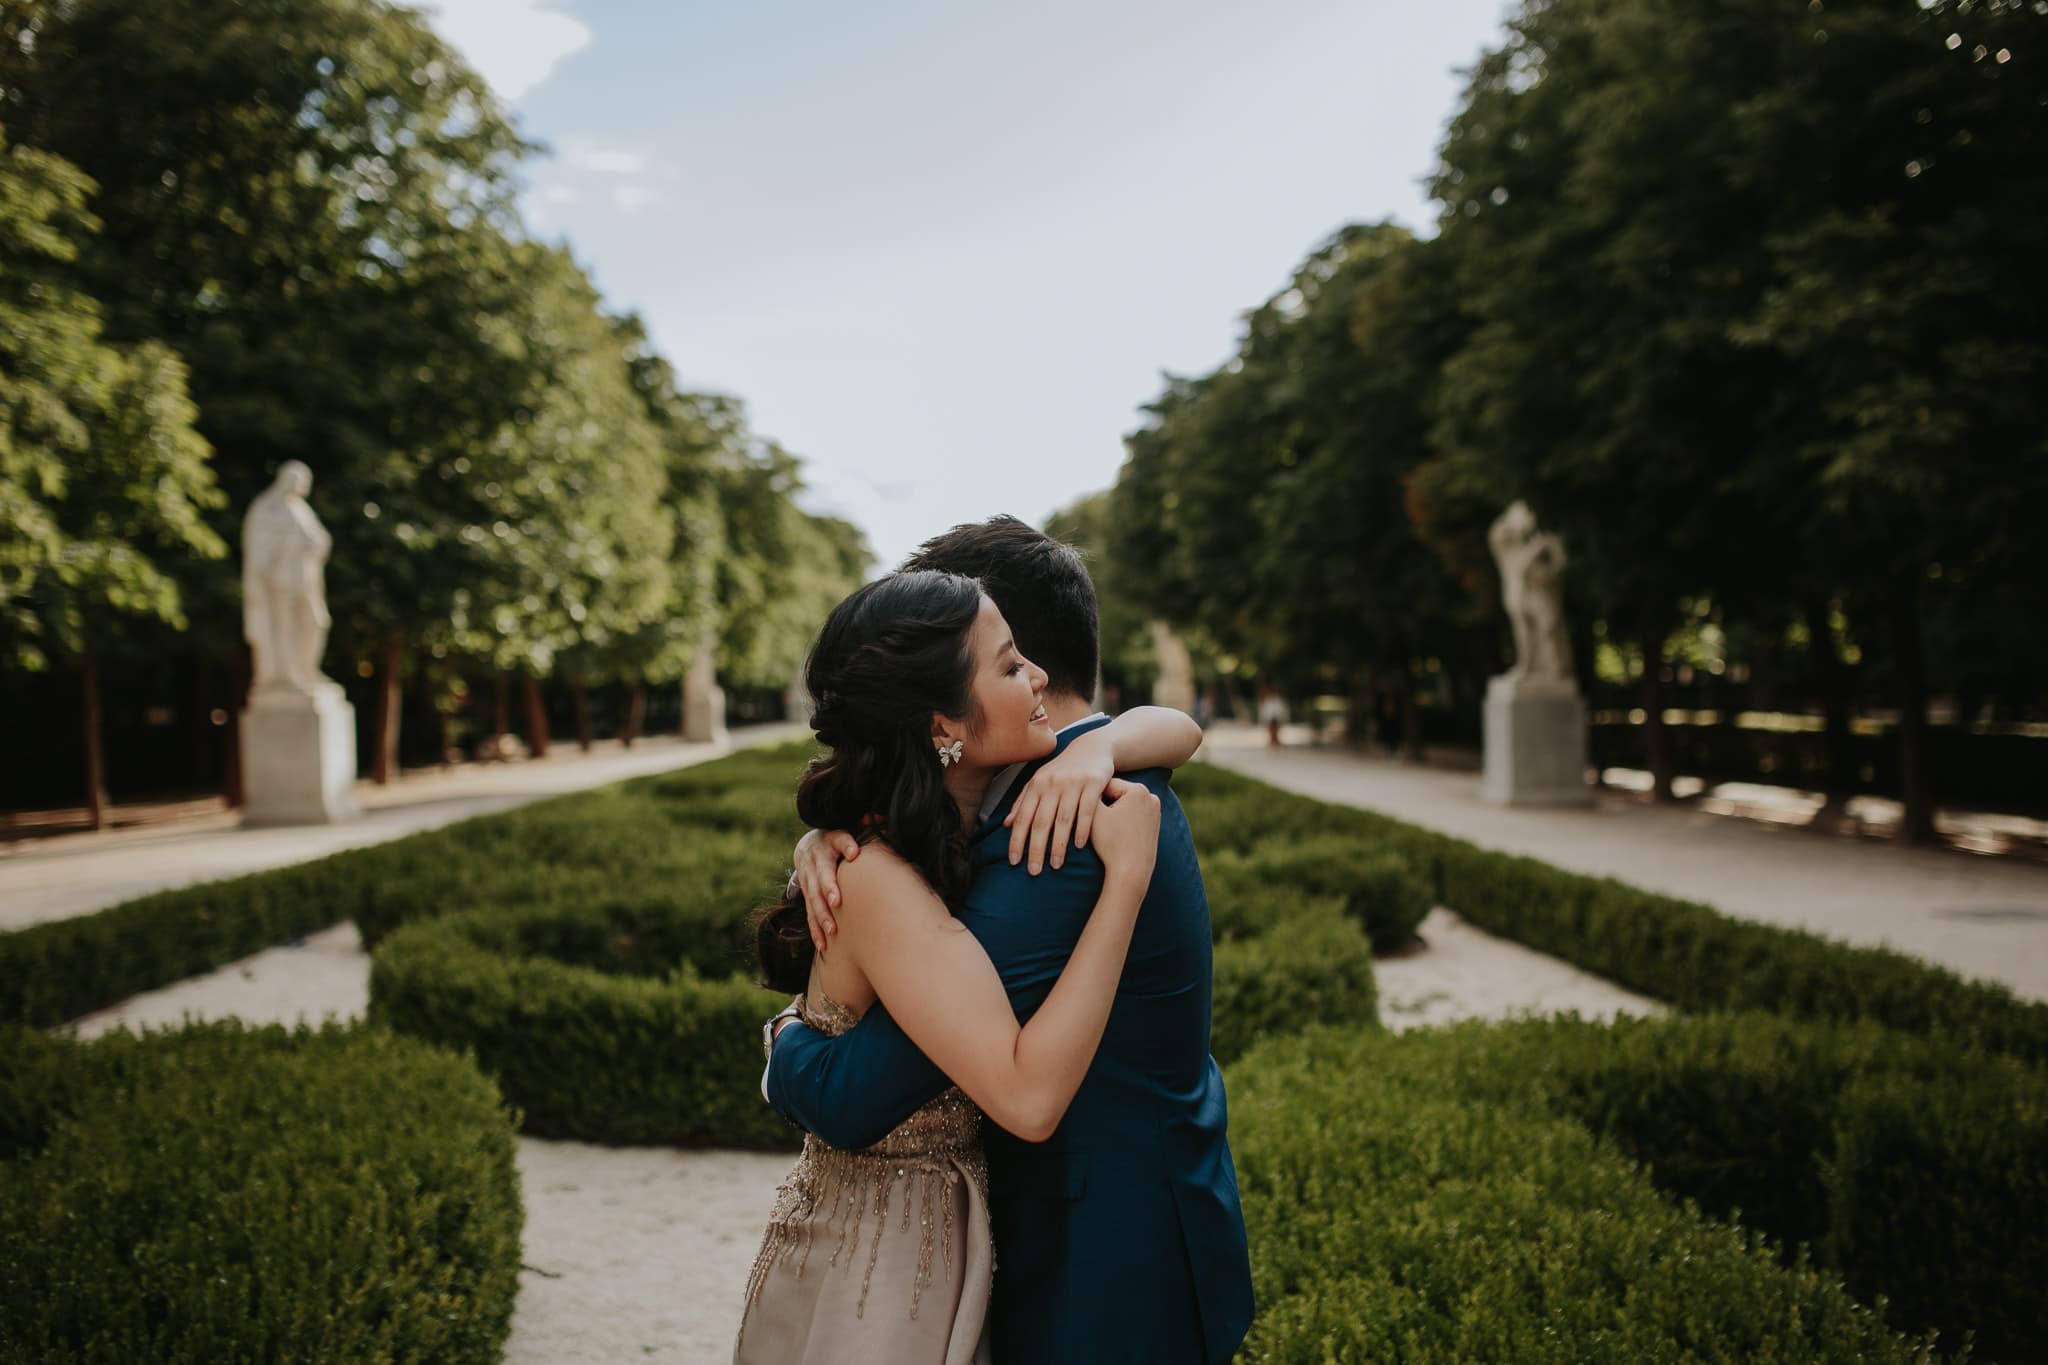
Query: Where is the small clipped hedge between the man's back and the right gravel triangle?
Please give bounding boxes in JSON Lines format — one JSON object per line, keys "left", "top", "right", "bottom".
{"left": 1208, "top": 900, "right": 1380, "bottom": 1062}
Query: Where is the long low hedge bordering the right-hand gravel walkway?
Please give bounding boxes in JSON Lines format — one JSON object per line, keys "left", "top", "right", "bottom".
{"left": 1174, "top": 763, "right": 2048, "bottom": 1062}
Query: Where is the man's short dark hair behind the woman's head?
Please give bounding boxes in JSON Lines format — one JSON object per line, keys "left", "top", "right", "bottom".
{"left": 901, "top": 516, "right": 1100, "bottom": 698}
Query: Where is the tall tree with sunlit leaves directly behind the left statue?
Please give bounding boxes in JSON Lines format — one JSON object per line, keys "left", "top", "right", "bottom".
{"left": 0, "top": 0, "right": 545, "bottom": 785}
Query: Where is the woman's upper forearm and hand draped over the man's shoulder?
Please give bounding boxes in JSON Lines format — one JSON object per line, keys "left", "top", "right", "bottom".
{"left": 1004, "top": 706, "right": 1202, "bottom": 876}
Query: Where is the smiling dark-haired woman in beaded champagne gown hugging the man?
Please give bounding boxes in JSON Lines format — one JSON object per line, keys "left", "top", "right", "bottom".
{"left": 735, "top": 573, "right": 1200, "bottom": 1365}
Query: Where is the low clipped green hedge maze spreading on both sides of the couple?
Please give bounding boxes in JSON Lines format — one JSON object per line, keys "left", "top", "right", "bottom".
{"left": 0, "top": 747, "right": 2048, "bottom": 1363}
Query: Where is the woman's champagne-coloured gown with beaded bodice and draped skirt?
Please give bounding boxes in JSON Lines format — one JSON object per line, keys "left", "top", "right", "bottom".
{"left": 733, "top": 982, "right": 995, "bottom": 1365}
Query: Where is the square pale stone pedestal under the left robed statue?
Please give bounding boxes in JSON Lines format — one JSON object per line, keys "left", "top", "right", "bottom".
{"left": 242, "top": 679, "right": 360, "bottom": 825}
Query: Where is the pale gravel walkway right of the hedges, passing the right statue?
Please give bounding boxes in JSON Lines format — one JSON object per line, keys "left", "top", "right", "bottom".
{"left": 1202, "top": 724, "right": 2048, "bottom": 1001}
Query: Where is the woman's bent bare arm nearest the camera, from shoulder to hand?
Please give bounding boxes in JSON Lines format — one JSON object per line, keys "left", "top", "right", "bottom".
{"left": 836, "top": 782, "right": 1159, "bottom": 1142}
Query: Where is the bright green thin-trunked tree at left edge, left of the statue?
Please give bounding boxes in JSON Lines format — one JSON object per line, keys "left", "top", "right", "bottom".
{"left": 0, "top": 129, "right": 225, "bottom": 827}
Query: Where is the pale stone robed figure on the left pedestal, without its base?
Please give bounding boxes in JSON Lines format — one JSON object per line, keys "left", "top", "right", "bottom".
{"left": 242, "top": 460, "right": 340, "bottom": 696}
